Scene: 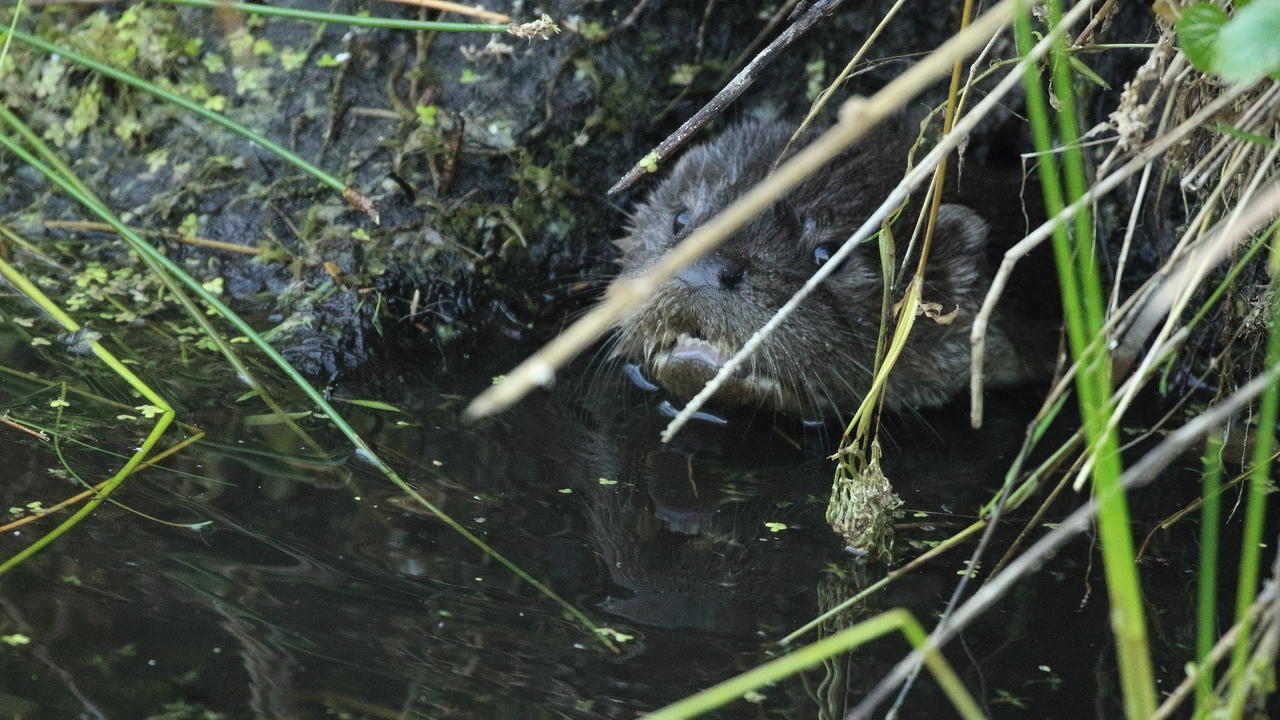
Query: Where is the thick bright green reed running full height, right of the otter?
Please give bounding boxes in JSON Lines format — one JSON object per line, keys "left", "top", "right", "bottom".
{"left": 1015, "top": 0, "right": 1156, "bottom": 720}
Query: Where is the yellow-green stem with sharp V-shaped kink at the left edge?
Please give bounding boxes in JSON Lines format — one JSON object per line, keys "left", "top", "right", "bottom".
{"left": 0, "top": 254, "right": 174, "bottom": 575}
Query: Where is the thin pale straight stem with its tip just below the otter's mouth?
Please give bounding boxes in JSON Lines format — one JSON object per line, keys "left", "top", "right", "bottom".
{"left": 662, "top": 0, "right": 1089, "bottom": 442}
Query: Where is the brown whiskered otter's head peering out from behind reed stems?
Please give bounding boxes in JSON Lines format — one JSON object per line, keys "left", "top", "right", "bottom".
{"left": 613, "top": 123, "right": 1042, "bottom": 418}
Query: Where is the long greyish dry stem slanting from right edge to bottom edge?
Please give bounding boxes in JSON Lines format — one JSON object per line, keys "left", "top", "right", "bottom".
{"left": 846, "top": 365, "right": 1280, "bottom": 720}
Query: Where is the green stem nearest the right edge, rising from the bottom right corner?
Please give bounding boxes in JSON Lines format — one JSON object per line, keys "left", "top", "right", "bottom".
{"left": 1228, "top": 248, "right": 1280, "bottom": 717}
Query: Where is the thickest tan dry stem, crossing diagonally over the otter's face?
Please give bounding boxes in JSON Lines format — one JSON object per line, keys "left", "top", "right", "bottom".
{"left": 463, "top": 0, "right": 1024, "bottom": 419}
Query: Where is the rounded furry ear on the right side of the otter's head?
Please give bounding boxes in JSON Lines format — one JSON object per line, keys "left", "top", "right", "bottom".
{"left": 924, "top": 204, "right": 989, "bottom": 302}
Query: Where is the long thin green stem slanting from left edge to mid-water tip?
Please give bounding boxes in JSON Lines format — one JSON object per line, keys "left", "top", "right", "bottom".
{"left": 0, "top": 131, "right": 616, "bottom": 651}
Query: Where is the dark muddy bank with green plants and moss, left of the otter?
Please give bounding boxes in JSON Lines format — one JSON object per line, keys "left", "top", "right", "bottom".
{"left": 0, "top": 0, "right": 1064, "bottom": 377}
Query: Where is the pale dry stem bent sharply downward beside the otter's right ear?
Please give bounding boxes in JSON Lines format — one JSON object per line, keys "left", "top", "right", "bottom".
{"left": 969, "top": 79, "right": 1251, "bottom": 428}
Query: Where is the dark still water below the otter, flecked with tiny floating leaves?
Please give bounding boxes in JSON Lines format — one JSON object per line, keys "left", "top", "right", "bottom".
{"left": 0, "top": 320, "right": 1218, "bottom": 719}
